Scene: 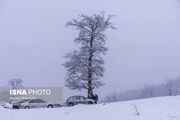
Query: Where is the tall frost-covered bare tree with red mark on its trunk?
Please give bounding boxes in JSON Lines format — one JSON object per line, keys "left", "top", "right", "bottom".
{"left": 63, "top": 13, "right": 114, "bottom": 98}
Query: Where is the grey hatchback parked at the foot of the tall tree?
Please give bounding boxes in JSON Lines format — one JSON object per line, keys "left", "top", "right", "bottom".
{"left": 66, "top": 95, "right": 95, "bottom": 106}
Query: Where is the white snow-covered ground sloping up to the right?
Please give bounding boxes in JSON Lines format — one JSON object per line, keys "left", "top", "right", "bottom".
{"left": 0, "top": 96, "right": 180, "bottom": 120}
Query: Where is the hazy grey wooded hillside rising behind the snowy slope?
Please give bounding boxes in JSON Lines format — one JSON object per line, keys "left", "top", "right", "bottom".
{"left": 104, "top": 78, "right": 180, "bottom": 102}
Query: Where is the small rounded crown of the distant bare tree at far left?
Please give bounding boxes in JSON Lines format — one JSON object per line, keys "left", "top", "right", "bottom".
{"left": 8, "top": 79, "right": 23, "bottom": 89}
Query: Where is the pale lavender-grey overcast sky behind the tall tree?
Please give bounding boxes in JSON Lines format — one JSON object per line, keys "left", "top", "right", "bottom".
{"left": 0, "top": 0, "right": 180, "bottom": 97}
